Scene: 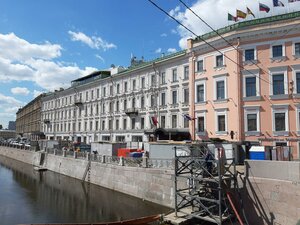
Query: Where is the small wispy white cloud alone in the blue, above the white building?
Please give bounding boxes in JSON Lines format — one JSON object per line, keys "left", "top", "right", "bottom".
{"left": 68, "top": 30, "right": 117, "bottom": 51}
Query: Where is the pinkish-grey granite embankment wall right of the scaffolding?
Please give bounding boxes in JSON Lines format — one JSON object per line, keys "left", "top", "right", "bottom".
{"left": 242, "top": 160, "right": 300, "bottom": 225}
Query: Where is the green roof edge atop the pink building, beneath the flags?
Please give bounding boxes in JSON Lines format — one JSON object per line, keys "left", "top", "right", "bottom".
{"left": 194, "top": 11, "right": 300, "bottom": 41}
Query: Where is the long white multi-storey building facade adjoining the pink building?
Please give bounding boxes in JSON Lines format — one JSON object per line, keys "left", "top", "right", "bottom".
{"left": 42, "top": 51, "right": 189, "bottom": 143}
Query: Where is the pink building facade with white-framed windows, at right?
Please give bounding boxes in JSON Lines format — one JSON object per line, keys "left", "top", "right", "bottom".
{"left": 188, "top": 12, "right": 300, "bottom": 159}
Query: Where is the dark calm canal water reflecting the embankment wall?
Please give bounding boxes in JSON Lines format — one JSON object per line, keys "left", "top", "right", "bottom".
{"left": 0, "top": 156, "right": 170, "bottom": 225}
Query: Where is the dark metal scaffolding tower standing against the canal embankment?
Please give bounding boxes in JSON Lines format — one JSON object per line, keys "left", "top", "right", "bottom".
{"left": 174, "top": 143, "right": 237, "bottom": 225}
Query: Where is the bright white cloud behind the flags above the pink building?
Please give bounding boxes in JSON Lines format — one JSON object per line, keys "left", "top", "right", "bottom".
{"left": 169, "top": 0, "right": 300, "bottom": 48}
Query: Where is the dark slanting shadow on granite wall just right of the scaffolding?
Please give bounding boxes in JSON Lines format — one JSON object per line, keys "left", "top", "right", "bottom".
{"left": 240, "top": 162, "right": 276, "bottom": 225}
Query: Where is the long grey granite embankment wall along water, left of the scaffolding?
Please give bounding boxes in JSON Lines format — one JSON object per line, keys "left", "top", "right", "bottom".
{"left": 0, "top": 146, "right": 174, "bottom": 207}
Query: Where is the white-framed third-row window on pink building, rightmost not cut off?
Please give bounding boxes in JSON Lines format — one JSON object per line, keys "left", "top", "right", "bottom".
{"left": 272, "top": 104, "right": 289, "bottom": 136}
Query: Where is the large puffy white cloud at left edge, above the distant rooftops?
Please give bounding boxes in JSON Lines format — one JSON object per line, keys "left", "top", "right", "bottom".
{"left": 0, "top": 33, "right": 96, "bottom": 90}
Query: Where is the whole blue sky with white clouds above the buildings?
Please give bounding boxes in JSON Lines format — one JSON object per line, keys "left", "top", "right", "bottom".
{"left": 0, "top": 0, "right": 300, "bottom": 127}
